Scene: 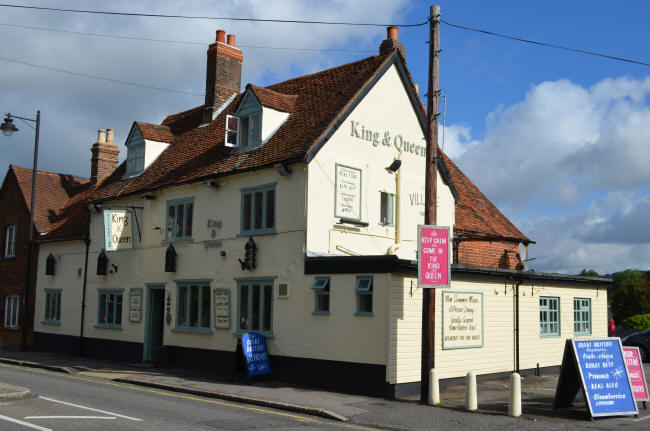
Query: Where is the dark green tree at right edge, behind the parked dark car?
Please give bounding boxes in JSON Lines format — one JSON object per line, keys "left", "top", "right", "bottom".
{"left": 611, "top": 269, "right": 650, "bottom": 322}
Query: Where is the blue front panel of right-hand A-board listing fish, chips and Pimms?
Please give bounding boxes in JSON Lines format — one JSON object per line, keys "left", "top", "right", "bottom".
{"left": 572, "top": 338, "right": 638, "bottom": 417}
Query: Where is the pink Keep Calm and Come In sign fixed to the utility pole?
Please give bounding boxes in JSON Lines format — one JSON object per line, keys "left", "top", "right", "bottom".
{"left": 418, "top": 225, "right": 451, "bottom": 288}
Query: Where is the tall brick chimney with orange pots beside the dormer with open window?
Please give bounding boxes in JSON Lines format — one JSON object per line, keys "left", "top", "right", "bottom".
{"left": 205, "top": 30, "right": 243, "bottom": 120}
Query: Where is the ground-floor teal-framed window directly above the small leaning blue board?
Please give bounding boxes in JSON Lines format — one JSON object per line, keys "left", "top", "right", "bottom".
{"left": 237, "top": 278, "right": 273, "bottom": 336}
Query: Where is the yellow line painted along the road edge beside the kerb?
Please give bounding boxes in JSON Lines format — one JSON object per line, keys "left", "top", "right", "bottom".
{"left": 0, "top": 363, "right": 377, "bottom": 431}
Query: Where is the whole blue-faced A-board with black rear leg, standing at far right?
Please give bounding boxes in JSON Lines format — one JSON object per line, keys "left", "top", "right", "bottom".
{"left": 553, "top": 337, "right": 639, "bottom": 418}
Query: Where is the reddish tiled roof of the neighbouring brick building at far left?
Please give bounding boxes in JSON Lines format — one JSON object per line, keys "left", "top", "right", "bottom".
{"left": 10, "top": 165, "right": 89, "bottom": 232}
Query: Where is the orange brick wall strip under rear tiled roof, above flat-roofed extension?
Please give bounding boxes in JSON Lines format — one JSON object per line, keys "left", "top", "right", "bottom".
{"left": 456, "top": 239, "right": 523, "bottom": 269}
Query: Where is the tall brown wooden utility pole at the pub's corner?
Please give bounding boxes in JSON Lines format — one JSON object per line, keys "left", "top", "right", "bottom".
{"left": 418, "top": 5, "right": 440, "bottom": 403}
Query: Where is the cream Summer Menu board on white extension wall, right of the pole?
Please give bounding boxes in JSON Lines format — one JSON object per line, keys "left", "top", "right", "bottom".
{"left": 442, "top": 291, "right": 483, "bottom": 350}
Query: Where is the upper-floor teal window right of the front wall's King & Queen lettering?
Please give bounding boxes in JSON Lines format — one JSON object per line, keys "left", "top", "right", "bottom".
{"left": 240, "top": 183, "right": 275, "bottom": 235}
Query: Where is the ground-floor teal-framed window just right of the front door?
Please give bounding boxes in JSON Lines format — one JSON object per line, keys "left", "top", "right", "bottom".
{"left": 174, "top": 280, "right": 212, "bottom": 333}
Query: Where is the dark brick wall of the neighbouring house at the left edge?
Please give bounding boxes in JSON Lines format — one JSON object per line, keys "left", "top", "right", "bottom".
{"left": 0, "top": 170, "right": 38, "bottom": 349}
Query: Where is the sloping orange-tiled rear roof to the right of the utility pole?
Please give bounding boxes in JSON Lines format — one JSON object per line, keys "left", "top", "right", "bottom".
{"left": 440, "top": 152, "right": 531, "bottom": 244}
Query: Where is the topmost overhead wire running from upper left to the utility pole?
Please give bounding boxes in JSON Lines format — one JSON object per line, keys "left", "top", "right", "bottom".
{"left": 0, "top": 3, "right": 429, "bottom": 27}
